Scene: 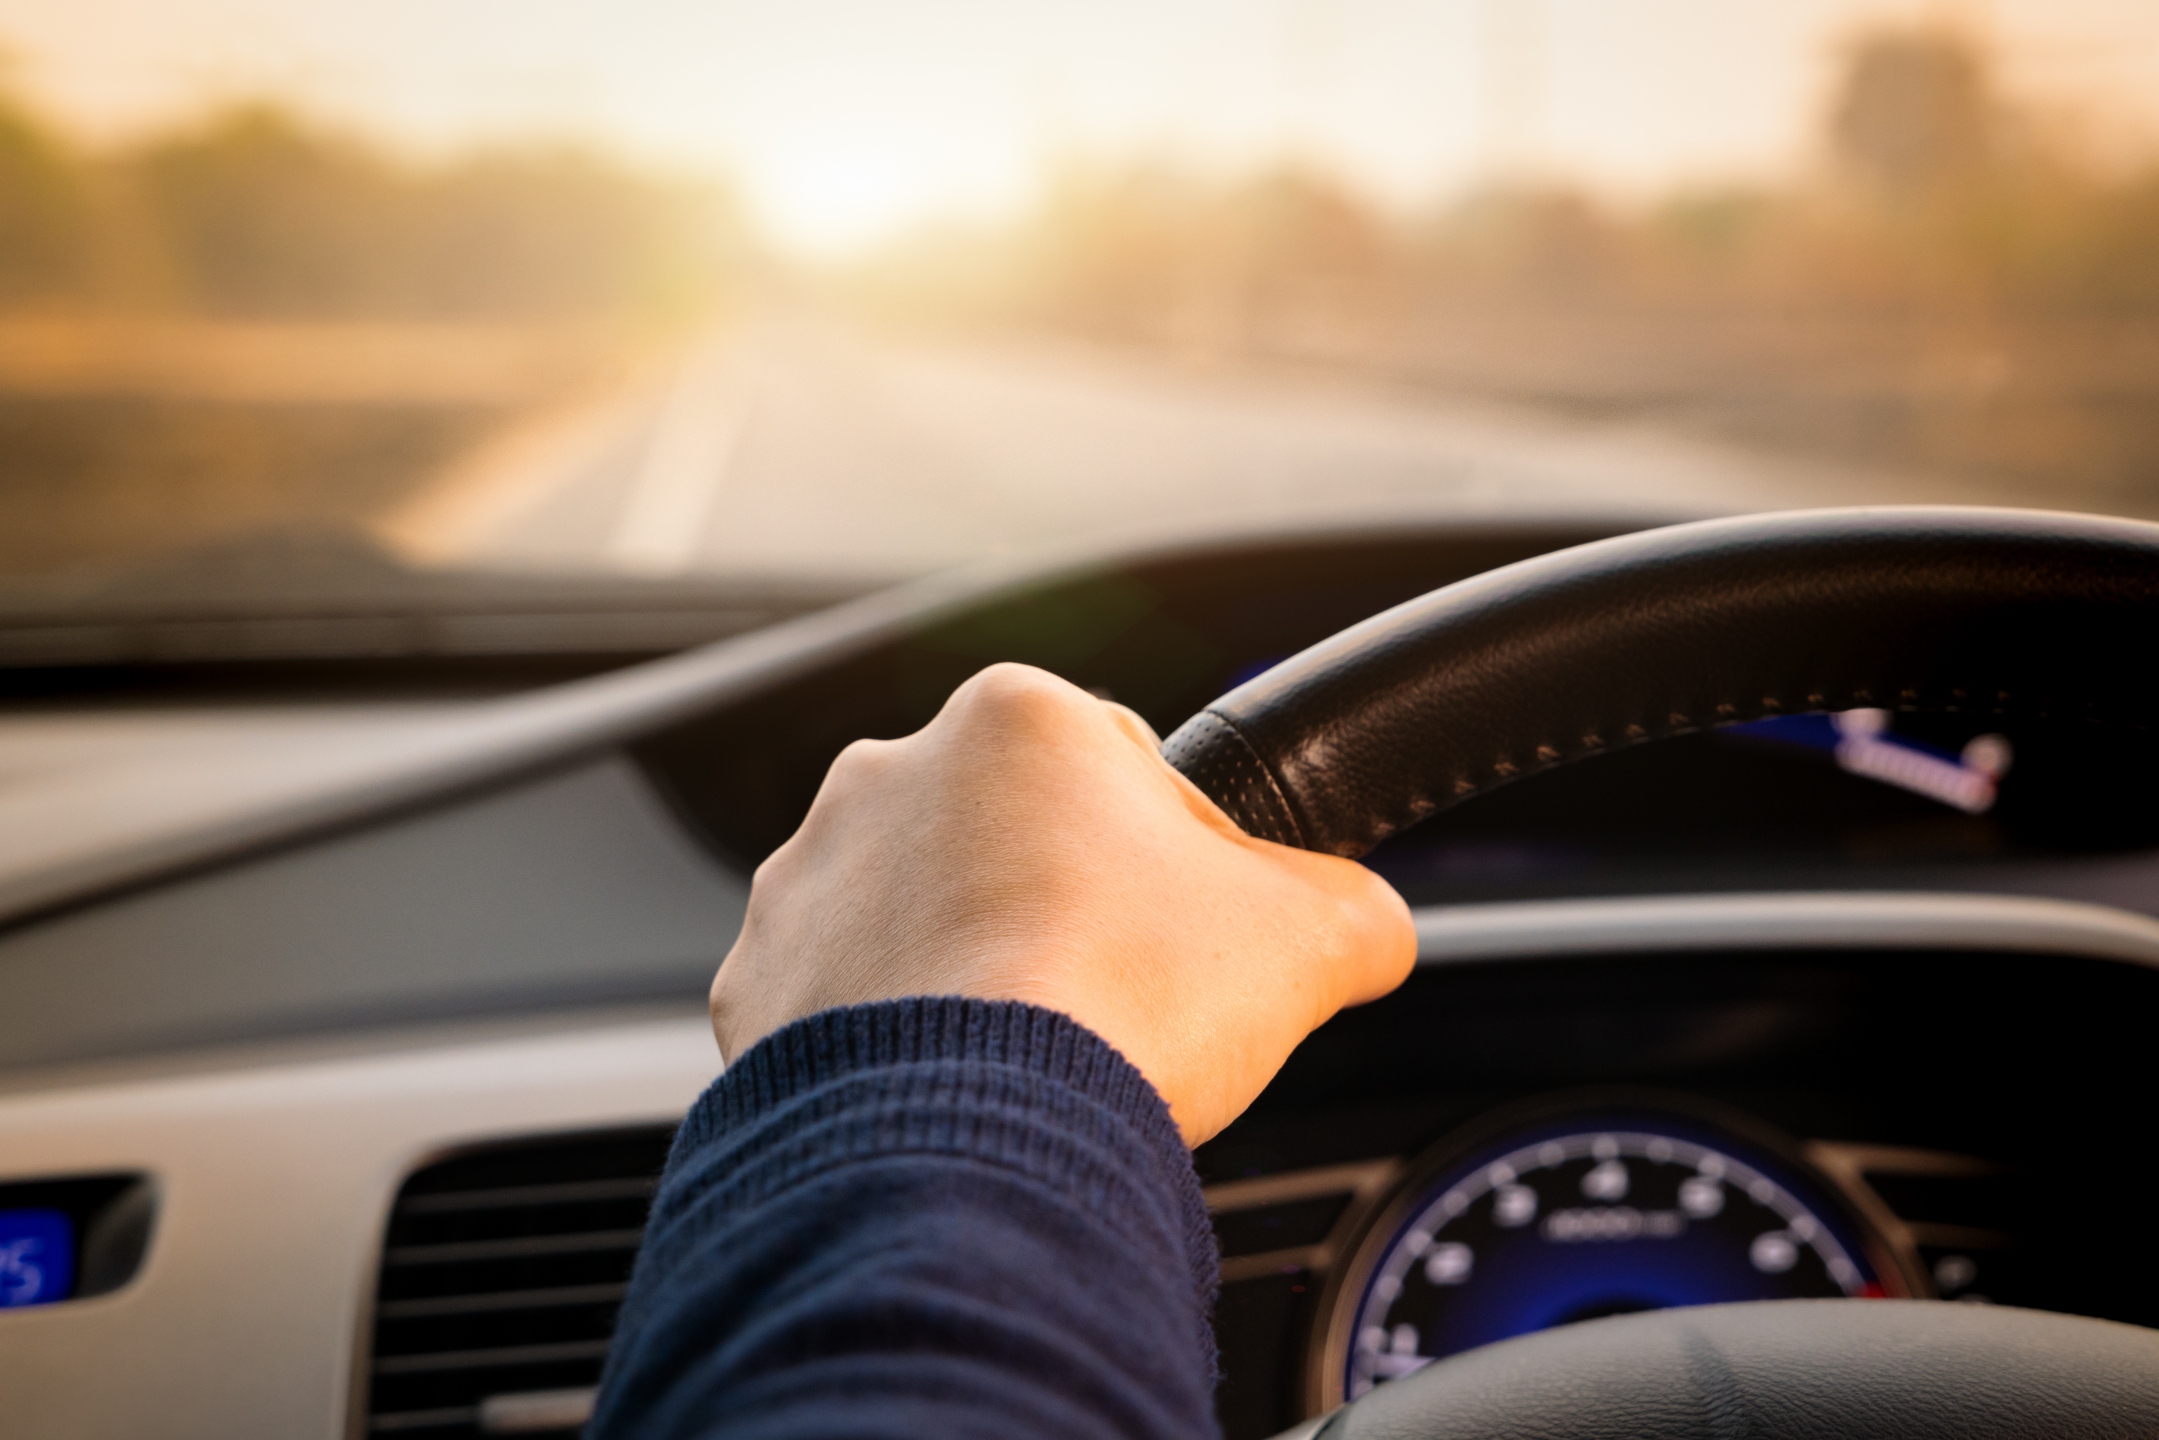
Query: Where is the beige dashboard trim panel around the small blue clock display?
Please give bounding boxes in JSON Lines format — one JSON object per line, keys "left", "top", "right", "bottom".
{"left": 0, "top": 1013, "right": 719, "bottom": 1440}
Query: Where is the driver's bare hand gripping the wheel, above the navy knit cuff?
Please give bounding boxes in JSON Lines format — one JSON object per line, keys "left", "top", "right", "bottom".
{"left": 712, "top": 665, "right": 1416, "bottom": 1144}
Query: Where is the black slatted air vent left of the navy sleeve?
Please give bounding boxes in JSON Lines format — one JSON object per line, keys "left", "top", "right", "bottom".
{"left": 367, "top": 1127, "right": 674, "bottom": 1440}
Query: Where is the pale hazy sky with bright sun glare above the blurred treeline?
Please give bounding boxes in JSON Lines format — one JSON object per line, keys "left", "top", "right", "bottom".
{"left": 0, "top": 0, "right": 2159, "bottom": 255}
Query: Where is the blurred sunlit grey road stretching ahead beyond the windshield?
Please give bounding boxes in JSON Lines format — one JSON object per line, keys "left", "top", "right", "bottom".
{"left": 388, "top": 326, "right": 1977, "bottom": 574}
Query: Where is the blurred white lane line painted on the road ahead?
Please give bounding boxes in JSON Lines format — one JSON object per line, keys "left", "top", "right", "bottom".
{"left": 605, "top": 345, "right": 753, "bottom": 574}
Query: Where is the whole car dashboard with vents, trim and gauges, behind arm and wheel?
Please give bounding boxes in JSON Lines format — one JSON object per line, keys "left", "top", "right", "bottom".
{"left": 0, "top": 522, "right": 2159, "bottom": 1440}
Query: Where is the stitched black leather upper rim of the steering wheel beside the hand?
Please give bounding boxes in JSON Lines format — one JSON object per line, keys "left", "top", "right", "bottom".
{"left": 1162, "top": 507, "right": 2159, "bottom": 855}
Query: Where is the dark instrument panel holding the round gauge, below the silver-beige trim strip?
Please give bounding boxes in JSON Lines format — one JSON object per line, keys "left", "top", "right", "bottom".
{"left": 1200, "top": 941, "right": 2159, "bottom": 1436}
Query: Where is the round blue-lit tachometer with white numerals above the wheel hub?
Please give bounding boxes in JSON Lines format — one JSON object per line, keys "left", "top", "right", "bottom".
{"left": 1321, "top": 1114, "right": 1909, "bottom": 1403}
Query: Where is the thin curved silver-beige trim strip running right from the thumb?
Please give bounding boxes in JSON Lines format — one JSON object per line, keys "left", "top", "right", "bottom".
{"left": 1416, "top": 892, "right": 2159, "bottom": 967}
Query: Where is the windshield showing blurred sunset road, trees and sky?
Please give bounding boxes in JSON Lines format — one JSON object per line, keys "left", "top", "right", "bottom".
{"left": 0, "top": 0, "right": 2159, "bottom": 609}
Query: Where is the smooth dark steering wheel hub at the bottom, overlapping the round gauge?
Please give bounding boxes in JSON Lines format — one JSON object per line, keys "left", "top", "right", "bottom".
{"left": 1313, "top": 1300, "right": 2159, "bottom": 1440}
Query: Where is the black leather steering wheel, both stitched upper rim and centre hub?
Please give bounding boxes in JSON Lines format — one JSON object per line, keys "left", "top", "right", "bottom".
{"left": 1162, "top": 507, "right": 2159, "bottom": 1440}
